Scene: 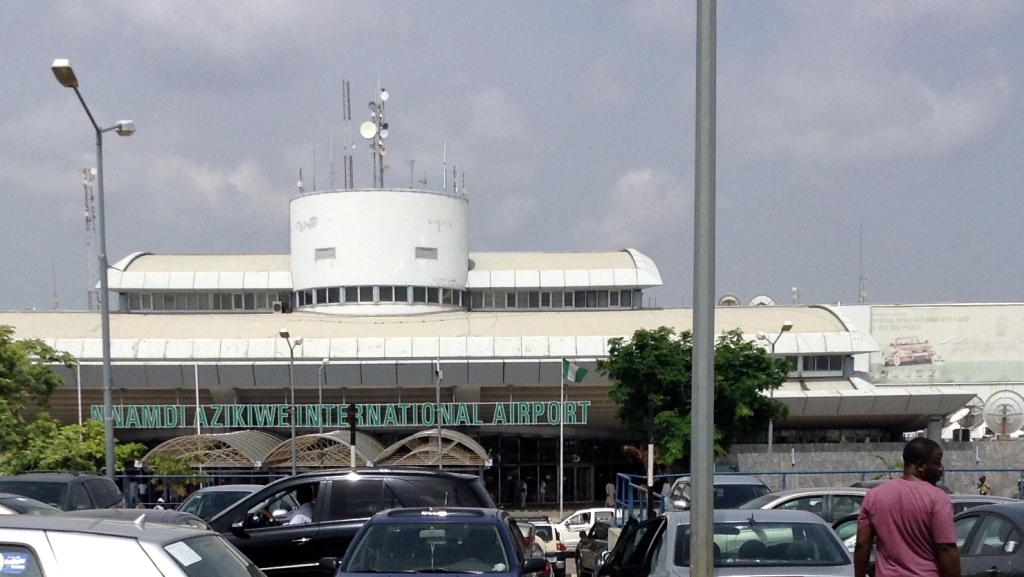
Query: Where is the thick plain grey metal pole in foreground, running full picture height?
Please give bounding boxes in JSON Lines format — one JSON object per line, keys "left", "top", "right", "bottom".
{"left": 690, "top": 0, "right": 717, "bottom": 577}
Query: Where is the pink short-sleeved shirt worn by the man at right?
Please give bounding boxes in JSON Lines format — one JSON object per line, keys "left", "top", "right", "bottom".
{"left": 857, "top": 478, "right": 956, "bottom": 577}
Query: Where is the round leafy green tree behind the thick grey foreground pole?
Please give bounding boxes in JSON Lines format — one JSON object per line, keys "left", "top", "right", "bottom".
{"left": 597, "top": 327, "right": 790, "bottom": 467}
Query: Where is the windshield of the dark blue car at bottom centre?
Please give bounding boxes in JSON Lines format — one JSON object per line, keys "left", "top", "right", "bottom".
{"left": 340, "top": 522, "right": 510, "bottom": 573}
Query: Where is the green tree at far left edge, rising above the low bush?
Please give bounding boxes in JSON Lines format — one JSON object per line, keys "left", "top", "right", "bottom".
{"left": 0, "top": 325, "right": 76, "bottom": 467}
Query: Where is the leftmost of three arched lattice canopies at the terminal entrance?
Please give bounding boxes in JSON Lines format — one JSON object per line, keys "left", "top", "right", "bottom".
{"left": 142, "top": 430, "right": 281, "bottom": 468}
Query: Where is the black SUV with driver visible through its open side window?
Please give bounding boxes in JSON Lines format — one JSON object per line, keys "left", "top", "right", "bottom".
{"left": 210, "top": 468, "right": 495, "bottom": 577}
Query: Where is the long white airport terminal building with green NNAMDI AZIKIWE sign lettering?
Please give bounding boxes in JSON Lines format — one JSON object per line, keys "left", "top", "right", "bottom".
{"left": 0, "top": 189, "right": 1024, "bottom": 502}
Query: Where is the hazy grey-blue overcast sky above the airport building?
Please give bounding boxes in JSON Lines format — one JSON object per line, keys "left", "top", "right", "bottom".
{"left": 0, "top": 0, "right": 1024, "bottom": 310}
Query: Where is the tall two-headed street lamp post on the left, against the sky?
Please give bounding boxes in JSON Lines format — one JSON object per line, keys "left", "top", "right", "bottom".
{"left": 50, "top": 58, "right": 135, "bottom": 480}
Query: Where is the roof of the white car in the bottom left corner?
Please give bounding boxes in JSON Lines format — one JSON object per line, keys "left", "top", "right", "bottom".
{"left": 0, "top": 514, "right": 216, "bottom": 545}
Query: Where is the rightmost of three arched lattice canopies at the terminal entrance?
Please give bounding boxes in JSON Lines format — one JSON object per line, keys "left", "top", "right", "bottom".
{"left": 374, "top": 428, "right": 487, "bottom": 467}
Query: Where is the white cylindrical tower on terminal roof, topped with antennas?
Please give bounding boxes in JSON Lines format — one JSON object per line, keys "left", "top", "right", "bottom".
{"left": 290, "top": 189, "right": 469, "bottom": 315}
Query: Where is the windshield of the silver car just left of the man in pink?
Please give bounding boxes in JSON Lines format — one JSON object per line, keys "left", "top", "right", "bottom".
{"left": 673, "top": 522, "right": 850, "bottom": 567}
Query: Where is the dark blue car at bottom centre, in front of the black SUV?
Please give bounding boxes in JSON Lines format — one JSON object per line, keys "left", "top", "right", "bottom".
{"left": 321, "top": 507, "right": 551, "bottom": 577}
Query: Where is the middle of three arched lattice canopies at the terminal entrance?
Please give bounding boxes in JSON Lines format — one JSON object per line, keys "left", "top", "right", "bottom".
{"left": 264, "top": 430, "right": 384, "bottom": 468}
